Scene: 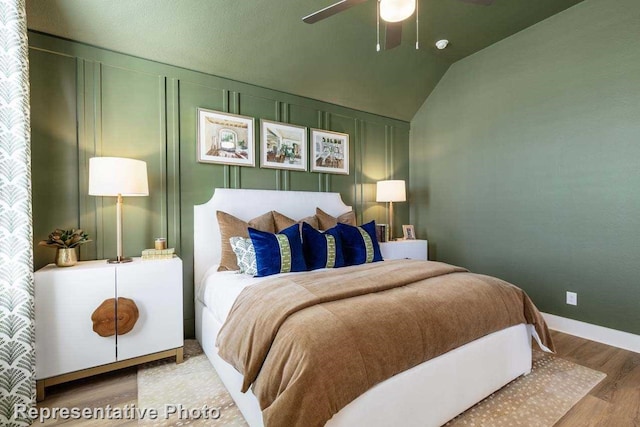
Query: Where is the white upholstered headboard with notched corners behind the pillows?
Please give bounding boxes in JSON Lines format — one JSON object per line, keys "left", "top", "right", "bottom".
{"left": 193, "top": 188, "right": 351, "bottom": 284}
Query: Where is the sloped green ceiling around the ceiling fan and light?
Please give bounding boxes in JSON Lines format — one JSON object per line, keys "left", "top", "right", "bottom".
{"left": 27, "top": 0, "right": 582, "bottom": 121}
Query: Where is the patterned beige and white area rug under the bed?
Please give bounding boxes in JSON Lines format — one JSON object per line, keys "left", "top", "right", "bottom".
{"left": 138, "top": 340, "right": 606, "bottom": 427}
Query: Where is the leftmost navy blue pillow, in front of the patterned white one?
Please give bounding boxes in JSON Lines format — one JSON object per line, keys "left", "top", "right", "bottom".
{"left": 249, "top": 224, "right": 307, "bottom": 277}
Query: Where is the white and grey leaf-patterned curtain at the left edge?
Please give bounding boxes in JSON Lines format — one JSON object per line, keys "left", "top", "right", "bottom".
{"left": 0, "top": 0, "right": 35, "bottom": 426}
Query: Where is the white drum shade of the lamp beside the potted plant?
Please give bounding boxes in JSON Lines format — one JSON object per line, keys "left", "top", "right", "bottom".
{"left": 89, "top": 157, "right": 149, "bottom": 196}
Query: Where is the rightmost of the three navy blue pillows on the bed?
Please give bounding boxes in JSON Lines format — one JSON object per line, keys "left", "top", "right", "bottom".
{"left": 336, "top": 221, "right": 382, "bottom": 265}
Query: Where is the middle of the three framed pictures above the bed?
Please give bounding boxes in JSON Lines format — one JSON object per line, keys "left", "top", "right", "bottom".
{"left": 260, "top": 120, "right": 308, "bottom": 171}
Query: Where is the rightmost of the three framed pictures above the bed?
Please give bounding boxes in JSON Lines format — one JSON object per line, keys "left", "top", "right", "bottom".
{"left": 311, "top": 129, "right": 349, "bottom": 175}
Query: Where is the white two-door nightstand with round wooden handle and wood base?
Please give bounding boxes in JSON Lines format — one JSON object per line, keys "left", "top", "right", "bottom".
{"left": 35, "top": 258, "right": 183, "bottom": 400}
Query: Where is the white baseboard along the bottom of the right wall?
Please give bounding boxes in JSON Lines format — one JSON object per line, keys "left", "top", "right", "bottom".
{"left": 542, "top": 313, "right": 640, "bottom": 353}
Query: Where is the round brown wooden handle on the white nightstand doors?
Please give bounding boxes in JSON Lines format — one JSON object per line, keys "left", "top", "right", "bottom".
{"left": 91, "top": 297, "right": 140, "bottom": 337}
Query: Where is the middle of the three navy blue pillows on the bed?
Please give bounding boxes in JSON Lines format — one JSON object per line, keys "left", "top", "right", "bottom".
{"left": 302, "top": 222, "right": 344, "bottom": 270}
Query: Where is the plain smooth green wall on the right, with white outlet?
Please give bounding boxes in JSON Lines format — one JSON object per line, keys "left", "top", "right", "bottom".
{"left": 410, "top": 0, "right": 640, "bottom": 334}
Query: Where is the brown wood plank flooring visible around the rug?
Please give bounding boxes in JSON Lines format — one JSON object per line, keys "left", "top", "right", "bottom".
{"left": 38, "top": 331, "right": 640, "bottom": 427}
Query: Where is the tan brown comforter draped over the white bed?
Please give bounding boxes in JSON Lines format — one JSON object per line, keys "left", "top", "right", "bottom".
{"left": 217, "top": 260, "right": 553, "bottom": 427}
